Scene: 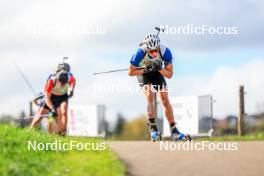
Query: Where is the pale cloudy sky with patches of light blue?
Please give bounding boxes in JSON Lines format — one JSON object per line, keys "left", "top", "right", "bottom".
{"left": 0, "top": 0, "right": 264, "bottom": 119}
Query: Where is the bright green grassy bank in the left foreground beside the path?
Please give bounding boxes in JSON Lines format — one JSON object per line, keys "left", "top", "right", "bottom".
{"left": 0, "top": 125, "right": 125, "bottom": 176}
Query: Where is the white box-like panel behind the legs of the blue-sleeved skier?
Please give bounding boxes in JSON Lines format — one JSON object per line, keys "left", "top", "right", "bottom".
{"left": 162, "top": 95, "right": 213, "bottom": 137}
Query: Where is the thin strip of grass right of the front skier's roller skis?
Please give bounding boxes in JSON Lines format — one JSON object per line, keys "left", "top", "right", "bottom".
{"left": 195, "top": 132, "right": 264, "bottom": 141}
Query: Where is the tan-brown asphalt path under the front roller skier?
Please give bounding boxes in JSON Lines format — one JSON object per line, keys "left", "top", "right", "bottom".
{"left": 108, "top": 141, "right": 264, "bottom": 176}
